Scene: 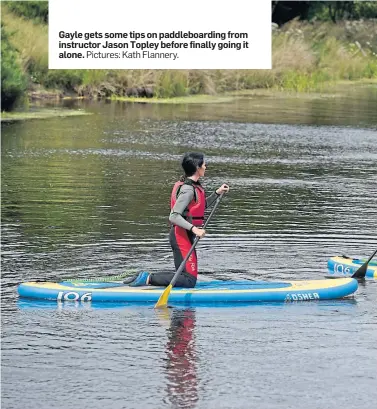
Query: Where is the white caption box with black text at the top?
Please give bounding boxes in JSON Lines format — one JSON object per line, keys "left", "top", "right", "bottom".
{"left": 49, "top": 0, "right": 271, "bottom": 69}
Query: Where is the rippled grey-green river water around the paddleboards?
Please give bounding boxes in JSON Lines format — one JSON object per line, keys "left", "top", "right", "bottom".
{"left": 2, "top": 86, "right": 377, "bottom": 409}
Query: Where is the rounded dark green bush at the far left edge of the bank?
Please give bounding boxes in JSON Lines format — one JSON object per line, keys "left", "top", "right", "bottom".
{"left": 1, "top": 24, "right": 26, "bottom": 111}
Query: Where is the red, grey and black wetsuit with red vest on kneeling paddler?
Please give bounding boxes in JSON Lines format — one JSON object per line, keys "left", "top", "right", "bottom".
{"left": 149, "top": 179, "right": 218, "bottom": 288}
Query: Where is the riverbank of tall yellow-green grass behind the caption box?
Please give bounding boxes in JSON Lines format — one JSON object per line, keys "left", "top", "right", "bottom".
{"left": 1, "top": 0, "right": 377, "bottom": 109}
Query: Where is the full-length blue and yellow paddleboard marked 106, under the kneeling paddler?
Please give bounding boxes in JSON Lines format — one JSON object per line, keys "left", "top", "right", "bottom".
{"left": 18, "top": 278, "right": 358, "bottom": 305}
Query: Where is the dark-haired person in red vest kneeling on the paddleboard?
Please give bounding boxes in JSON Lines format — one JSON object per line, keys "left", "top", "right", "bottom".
{"left": 124, "top": 152, "right": 229, "bottom": 288}
